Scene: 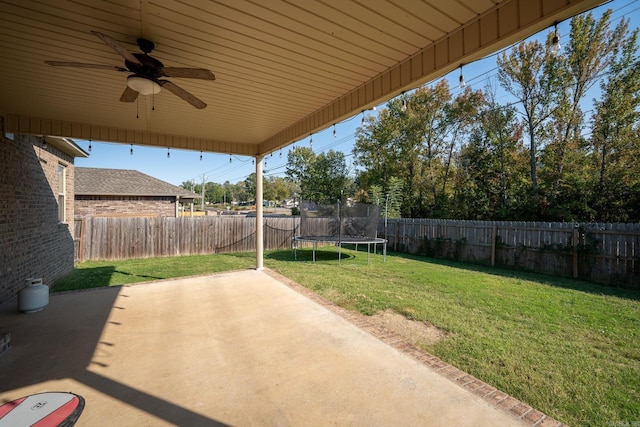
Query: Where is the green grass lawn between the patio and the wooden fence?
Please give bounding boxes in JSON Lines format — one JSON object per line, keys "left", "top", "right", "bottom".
{"left": 56, "top": 247, "right": 640, "bottom": 426}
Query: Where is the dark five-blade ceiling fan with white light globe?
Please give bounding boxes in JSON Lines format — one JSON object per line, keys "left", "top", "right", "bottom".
{"left": 44, "top": 31, "right": 216, "bottom": 109}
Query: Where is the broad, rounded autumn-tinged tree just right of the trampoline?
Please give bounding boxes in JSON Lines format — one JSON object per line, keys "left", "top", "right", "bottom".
{"left": 353, "top": 80, "right": 483, "bottom": 217}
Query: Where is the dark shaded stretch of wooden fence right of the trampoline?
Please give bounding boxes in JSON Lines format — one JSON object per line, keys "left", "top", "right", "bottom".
{"left": 378, "top": 218, "right": 640, "bottom": 288}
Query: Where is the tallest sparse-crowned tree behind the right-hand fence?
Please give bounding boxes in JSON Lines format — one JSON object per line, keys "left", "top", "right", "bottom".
{"left": 541, "top": 10, "right": 628, "bottom": 220}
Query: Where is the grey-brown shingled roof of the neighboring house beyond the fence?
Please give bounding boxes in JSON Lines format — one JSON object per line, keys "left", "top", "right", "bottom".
{"left": 75, "top": 167, "right": 201, "bottom": 201}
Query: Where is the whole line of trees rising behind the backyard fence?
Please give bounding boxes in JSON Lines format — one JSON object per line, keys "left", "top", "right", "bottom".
{"left": 182, "top": 10, "right": 640, "bottom": 222}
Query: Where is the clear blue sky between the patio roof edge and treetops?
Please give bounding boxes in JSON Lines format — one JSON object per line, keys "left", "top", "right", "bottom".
{"left": 76, "top": 0, "right": 640, "bottom": 185}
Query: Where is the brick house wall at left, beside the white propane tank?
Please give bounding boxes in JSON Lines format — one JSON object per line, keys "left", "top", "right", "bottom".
{"left": 0, "top": 134, "right": 74, "bottom": 304}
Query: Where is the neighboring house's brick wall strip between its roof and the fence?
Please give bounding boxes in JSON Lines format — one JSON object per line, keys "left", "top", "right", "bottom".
{"left": 75, "top": 195, "right": 176, "bottom": 217}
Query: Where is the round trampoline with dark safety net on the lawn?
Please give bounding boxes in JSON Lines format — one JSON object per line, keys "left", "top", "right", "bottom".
{"left": 293, "top": 201, "right": 387, "bottom": 264}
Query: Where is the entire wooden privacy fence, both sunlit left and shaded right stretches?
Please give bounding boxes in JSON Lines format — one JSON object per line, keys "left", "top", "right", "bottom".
{"left": 75, "top": 215, "right": 640, "bottom": 288}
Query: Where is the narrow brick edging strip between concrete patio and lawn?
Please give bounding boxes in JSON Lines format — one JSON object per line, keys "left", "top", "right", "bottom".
{"left": 264, "top": 268, "right": 567, "bottom": 427}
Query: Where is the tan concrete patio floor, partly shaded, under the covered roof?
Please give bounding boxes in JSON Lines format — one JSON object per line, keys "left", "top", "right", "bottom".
{"left": 0, "top": 270, "right": 557, "bottom": 426}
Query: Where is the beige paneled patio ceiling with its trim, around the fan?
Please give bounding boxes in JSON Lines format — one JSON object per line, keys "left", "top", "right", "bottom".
{"left": 0, "top": 0, "right": 603, "bottom": 156}
